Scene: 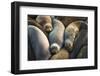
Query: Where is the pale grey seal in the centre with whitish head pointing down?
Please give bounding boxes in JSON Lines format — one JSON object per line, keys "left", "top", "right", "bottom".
{"left": 49, "top": 19, "right": 65, "bottom": 54}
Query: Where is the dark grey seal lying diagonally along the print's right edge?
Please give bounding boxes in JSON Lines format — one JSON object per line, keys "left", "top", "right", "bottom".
{"left": 70, "top": 30, "right": 88, "bottom": 59}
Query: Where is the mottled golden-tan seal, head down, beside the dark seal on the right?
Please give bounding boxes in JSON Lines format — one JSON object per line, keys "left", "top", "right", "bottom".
{"left": 64, "top": 21, "right": 87, "bottom": 52}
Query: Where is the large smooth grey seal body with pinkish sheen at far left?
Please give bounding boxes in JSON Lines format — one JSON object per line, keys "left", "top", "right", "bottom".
{"left": 28, "top": 25, "right": 51, "bottom": 60}
